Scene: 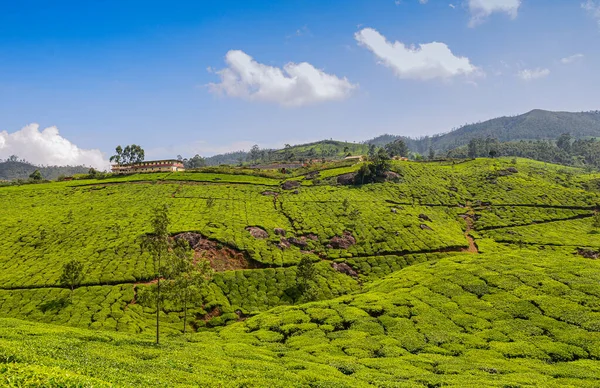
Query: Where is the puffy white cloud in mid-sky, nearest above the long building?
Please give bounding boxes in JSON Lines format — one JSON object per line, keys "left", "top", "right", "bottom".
{"left": 208, "top": 50, "right": 357, "bottom": 106}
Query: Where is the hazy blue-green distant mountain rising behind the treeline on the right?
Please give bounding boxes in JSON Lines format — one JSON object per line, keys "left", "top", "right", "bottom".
{"left": 366, "top": 109, "right": 600, "bottom": 153}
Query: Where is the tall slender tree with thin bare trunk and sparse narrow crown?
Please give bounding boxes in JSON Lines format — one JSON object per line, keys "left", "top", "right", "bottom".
{"left": 140, "top": 204, "right": 171, "bottom": 345}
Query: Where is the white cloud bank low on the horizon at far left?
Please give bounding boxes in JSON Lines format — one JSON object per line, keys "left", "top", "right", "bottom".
{"left": 0, "top": 124, "right": 110, "bottom": 170}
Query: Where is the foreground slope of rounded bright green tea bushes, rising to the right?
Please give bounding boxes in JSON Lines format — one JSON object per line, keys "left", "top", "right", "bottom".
{"left": 0, "top": 251, "right": 600, "bottom": 388}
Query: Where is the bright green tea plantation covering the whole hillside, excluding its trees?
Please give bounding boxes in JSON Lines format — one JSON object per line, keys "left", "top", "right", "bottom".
{"left": 0, "top": 159, "right": 600, "bottom": 387}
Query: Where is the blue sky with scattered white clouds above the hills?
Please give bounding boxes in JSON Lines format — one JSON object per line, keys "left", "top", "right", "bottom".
{"left": 0, "top": 0, "right": 600, "bottom": 165}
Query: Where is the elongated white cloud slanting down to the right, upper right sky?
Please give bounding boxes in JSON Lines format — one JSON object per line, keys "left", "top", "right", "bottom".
{"left": 354, "top": 28, "right": 481, "bottom": 80}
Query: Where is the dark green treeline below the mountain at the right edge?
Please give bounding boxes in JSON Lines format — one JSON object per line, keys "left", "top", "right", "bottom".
{"left": 447, "top": 133, "right": 600, "bottom": 168}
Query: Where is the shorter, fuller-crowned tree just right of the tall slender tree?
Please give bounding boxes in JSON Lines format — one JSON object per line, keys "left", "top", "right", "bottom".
{"left": 165, "top": 239, "right": 213, "bottom": 334}
